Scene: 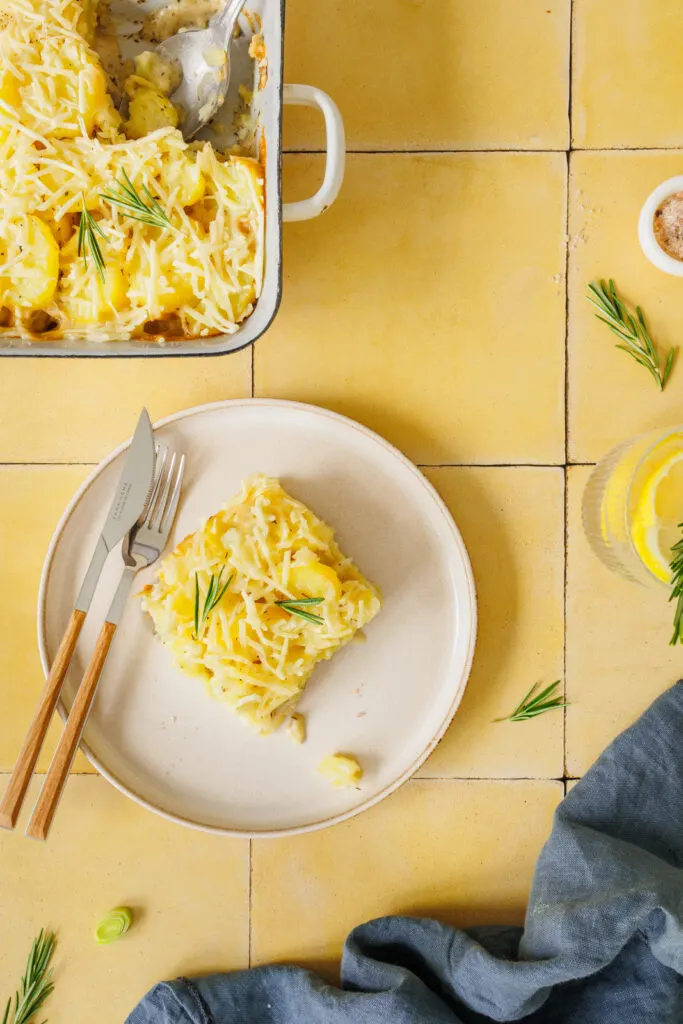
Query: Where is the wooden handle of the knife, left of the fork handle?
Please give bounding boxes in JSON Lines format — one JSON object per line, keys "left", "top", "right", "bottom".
{"left": 0, "top": 609, "right": 85, "bottom": 828}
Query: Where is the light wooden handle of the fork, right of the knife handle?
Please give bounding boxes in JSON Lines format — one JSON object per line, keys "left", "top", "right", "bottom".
{"left": 26, "top": 622, "right": 116, "bottom": 840}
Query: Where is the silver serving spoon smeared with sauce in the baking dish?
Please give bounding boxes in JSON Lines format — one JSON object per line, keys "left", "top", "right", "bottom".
{"left": 156, "top": 0, "right": 246, "bottom": 141}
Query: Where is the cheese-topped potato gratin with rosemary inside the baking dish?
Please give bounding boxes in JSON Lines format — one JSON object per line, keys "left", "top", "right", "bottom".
{"left": 0, "top": 0, "right": 264, "bottom": 344}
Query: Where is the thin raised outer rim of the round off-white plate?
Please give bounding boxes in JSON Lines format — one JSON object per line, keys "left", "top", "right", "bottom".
{"left": 37, "top": 398, "right": 477, "bottom": 839}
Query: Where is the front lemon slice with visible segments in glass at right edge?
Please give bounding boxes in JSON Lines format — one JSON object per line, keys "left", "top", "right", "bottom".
{"left": 631, "top": 451, "right": 683, "bottom": 583}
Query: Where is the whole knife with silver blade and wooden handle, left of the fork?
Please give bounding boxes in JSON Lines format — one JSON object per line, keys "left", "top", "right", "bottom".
{"left": 0, "top": 409, "right": 156, "bottom": 828}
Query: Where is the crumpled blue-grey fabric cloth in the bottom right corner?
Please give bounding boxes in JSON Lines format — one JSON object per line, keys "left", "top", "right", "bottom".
{"left": 127, "top": 682, "right": 683, "bottom": 1024}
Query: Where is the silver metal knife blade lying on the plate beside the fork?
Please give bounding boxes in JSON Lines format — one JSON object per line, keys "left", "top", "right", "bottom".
{"left": 75, "top": 409, "right": 156, "bottom": 612}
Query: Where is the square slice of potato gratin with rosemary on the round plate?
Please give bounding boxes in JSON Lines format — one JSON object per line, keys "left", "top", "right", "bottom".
{"left": 141, "top": 475, "right": 381, "bottom": 733}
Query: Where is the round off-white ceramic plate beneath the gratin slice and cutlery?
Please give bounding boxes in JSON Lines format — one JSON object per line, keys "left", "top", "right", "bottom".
{"left": 38, "top": 399, "right": 476, "bottom": 836}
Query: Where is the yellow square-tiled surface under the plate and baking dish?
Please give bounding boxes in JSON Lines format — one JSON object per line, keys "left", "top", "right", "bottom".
{"left": 0, "top": 0, "right": 683, "bottom": 1024}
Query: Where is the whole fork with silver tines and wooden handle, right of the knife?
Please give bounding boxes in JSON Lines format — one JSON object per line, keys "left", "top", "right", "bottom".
{"left": 26, "top": 447, "right": 185, "bottom": 840}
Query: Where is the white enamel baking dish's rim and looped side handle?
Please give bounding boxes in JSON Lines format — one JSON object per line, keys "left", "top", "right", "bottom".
{"left": 0, "top": 0, "right": 345, "bottom": 357}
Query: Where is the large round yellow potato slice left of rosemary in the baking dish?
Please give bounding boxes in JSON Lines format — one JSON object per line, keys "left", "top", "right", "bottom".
{"left": 10, "top": 216, "right": 59, "bottom": 309}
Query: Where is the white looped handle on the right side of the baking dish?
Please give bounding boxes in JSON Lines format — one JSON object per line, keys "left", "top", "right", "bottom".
{"left": 283, "top": 85, "right": 346, "bottom": 220}
